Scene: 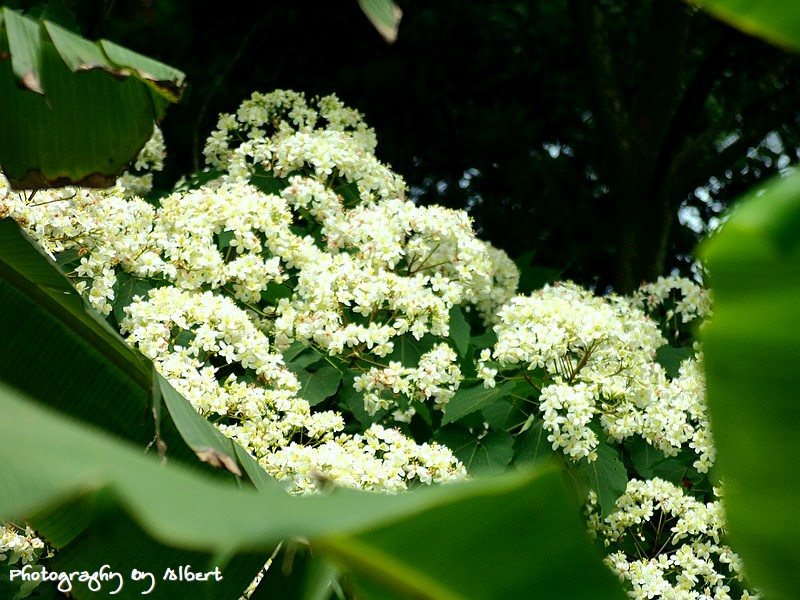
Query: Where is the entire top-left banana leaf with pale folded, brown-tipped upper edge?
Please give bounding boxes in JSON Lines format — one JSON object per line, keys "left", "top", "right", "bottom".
{"left": 0, "top": 7, "right": 184, "bottom": 189}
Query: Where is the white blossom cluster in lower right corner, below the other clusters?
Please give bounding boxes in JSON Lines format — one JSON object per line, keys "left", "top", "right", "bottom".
{"left": 587, "top": 478, "right": 758, "bottom": 600}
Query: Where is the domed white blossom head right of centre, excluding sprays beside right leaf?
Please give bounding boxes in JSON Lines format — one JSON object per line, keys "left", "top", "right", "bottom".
{"left": 481, "top": 282, "right": 664, "bottom": 460}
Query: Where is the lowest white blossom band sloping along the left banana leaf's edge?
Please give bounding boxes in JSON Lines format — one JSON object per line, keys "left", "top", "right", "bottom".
{"left": 122, "top": 286, "right": 465, "bottom": 493}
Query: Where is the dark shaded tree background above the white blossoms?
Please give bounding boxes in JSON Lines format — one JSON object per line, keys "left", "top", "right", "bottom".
{"left": 9, "top": 0, "right": 800, "bottom": 292}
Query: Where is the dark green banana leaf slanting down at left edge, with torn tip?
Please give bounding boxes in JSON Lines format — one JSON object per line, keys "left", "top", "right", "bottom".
{"left": 0, "top": 219, "right": 247, "bottom": 478}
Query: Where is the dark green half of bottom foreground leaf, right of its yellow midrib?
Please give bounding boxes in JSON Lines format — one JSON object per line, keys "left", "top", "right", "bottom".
{"left": 320, "top": 468, "right": 623, "bottom": 600}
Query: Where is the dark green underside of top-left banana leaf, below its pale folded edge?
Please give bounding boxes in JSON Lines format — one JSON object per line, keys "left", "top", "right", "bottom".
{"left": 0, "top": 42, "right": 156, "bottom": 189}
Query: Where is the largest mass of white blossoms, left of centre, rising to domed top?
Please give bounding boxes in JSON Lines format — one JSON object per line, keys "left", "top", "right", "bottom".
{"left": 0, "top": 92, "right": 518, "bottom": 492}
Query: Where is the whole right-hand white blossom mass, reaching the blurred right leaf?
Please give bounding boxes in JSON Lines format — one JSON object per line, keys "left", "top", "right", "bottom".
{"left": 478, "top": 282, "right": 714, "bottom": 472}
